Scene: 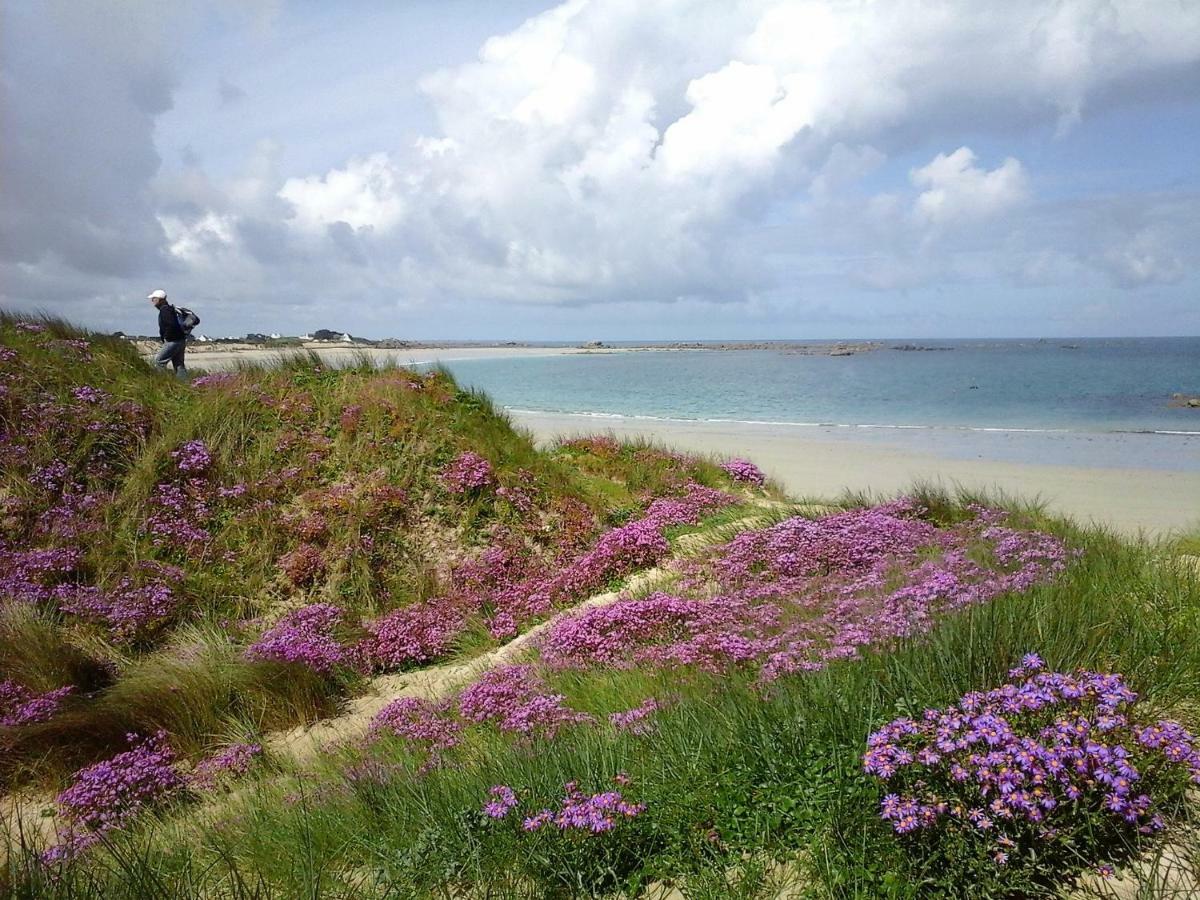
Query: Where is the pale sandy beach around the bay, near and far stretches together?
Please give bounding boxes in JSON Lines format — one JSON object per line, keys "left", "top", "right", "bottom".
{"left": 162, "top": 346, "right": 1200, "bottom": 536}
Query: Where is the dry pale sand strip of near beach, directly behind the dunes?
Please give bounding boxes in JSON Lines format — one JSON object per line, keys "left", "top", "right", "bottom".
{"left": 509, "top": 410, "right": 1200, "bottom": 538}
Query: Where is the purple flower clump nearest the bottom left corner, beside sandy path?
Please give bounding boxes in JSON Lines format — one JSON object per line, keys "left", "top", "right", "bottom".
{"left": 46, "top": 731, "right": 184, "bottom": 863}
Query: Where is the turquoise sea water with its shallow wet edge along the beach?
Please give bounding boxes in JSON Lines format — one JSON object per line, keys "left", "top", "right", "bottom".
{"left": 432, "top": 337, "right": 1200, "bottom": 470}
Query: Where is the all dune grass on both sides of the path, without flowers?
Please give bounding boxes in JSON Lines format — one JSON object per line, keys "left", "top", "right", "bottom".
{"left": 0, "top": 316, "right": 1200, "bottom": 900}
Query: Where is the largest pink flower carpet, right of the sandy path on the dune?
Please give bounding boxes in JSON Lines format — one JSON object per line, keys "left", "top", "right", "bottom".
{"left": 539, "top": 505, "right": 1067, "bottom": 682}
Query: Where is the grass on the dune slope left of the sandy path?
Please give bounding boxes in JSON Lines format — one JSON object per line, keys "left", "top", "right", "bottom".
{"left": 0, "top": 313, "right": 768, "bottom": 788}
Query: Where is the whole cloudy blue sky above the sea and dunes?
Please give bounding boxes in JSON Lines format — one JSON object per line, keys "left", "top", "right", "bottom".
{"left": 0, "top": 0, "right": 1200, "bottom": 341}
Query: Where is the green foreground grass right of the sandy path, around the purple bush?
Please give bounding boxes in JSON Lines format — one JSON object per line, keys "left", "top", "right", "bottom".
{"left": 2, "top": 503, "right": 1200, "bottom": 898}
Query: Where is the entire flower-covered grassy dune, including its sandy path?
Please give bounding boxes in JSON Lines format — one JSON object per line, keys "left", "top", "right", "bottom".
{"left": 0, "top": 317, "right": 1200, "bottom": 898}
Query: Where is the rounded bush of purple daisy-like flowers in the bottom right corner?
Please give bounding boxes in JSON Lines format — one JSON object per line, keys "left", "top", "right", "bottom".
{"left": 863, "top": 654, "right": 1200, "bottom": 878}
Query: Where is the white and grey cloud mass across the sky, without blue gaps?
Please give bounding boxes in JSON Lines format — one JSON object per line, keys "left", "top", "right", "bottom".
{"left": 0, "top": 0, "right": 1200, "bottom": 330}
